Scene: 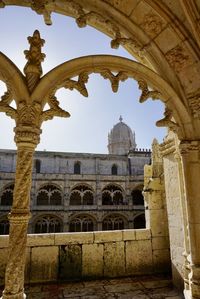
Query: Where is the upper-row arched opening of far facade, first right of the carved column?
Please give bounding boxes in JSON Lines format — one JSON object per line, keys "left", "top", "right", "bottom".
{"left": 37, "top": 185, "right": 62, "bottom": 206}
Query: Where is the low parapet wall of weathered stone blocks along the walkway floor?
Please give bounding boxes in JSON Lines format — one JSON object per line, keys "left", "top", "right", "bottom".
{"left": 0, "top": 229, "right": 170, "bottom": 284}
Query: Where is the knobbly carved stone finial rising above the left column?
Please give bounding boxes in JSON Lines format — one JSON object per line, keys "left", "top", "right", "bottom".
{"left": 24, "top": 30, "right": 45, "bottom": 92}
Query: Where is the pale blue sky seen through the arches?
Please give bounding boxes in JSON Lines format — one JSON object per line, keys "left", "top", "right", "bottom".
{"left": 0, "top": 6, "right": 166, "bottom": 153}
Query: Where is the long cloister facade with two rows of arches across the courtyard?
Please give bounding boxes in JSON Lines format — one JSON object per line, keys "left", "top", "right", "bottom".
{"left": 0, "top": 121, "right": 151, "bottom": 234}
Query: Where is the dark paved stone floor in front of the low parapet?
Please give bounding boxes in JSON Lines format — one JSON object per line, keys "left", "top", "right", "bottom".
{"left": 19, "top": 276, "right": 183, "bottom": 299}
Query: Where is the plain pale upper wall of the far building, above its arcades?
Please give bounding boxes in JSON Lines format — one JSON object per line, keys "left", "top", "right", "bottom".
{"left": 0, "top": 150, "right": 151, "bottom": 176}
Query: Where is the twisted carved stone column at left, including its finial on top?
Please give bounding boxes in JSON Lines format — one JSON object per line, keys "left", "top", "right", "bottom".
{"left": 0, "top": 30, "right": 70, "bottom": 299}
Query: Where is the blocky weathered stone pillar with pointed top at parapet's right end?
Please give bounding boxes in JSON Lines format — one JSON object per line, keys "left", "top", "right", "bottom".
{"left": 143, "top": 139, "right": 170, "bottom": 272}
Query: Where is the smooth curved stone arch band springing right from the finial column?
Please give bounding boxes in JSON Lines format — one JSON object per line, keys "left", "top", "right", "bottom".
{"left": 31, "top": 55, "right": 192, "bottom": 139}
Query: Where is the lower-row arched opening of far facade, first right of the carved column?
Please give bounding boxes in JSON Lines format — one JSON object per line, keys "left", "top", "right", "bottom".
{"left": 34, "top": 216, "right": 62, "bottom": 234}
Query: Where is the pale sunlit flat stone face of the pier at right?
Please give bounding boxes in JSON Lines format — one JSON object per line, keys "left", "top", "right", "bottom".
{"left": 161, "top": 132, "right": 186, "bottom": 288}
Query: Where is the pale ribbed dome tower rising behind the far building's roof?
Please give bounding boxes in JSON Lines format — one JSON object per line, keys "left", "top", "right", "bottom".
{"left": 108, "top": 116, "right": 136, "bottom": 155}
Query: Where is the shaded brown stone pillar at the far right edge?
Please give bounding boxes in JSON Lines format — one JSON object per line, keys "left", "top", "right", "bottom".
{"left": 180, "top": 141, "right": 200, "bottom": 299}
